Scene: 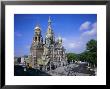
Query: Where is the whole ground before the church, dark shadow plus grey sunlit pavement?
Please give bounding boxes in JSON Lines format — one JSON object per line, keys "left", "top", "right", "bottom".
{"left": 14, "top": 63, "right": 97, "bottom": 76}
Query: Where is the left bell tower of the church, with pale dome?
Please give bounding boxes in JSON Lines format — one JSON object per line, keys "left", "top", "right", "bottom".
{"left": 30, "top": 25, "right": 43, "bottom": 68}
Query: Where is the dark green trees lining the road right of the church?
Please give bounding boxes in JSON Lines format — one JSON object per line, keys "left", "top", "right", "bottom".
{"left": 67, "top": 39, "right": 97, "bottom": 65}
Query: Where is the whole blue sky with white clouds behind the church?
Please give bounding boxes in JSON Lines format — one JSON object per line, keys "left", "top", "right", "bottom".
{"left": 14, "top": 14, "right": 97, "bottom": 56}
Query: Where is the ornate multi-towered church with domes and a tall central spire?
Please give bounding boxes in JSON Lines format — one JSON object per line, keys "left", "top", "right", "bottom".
{"left": 29, "top": 17, "right": 67, "bottom": 71}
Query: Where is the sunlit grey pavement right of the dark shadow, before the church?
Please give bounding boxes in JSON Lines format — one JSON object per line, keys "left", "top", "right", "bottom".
{"left": 47, "top": 64, "right": 95, "bottom": 76}
